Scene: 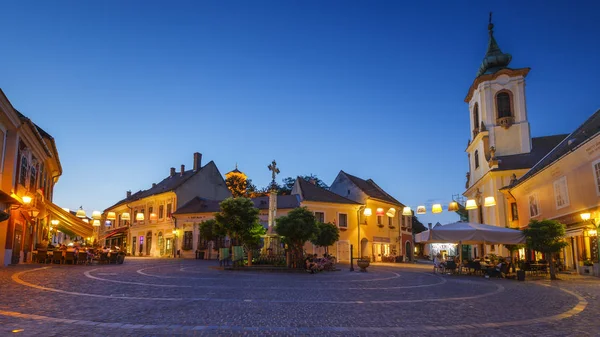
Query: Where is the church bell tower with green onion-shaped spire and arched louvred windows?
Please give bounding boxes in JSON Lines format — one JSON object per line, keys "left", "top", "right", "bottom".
{"left": 465, "top": 13, "right": 531, "bottom": 186}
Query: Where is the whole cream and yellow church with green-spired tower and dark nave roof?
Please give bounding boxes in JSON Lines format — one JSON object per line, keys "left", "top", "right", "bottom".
{"left": 463, "top": 18, "right": 567, "bottom": 257}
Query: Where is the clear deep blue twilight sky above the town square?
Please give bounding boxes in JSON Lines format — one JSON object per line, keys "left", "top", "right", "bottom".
{"left": 0, "top": 0, "right": 600, "bottom": 223}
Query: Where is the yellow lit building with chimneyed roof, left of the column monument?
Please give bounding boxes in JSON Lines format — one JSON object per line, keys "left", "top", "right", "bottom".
{"left": 99, "top": 152, "right": 231, "bottom": 257}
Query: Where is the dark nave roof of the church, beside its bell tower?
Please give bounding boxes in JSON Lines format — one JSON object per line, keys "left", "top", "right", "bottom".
{"left": 492, "top": 134, "right": 568, "bottom": 171}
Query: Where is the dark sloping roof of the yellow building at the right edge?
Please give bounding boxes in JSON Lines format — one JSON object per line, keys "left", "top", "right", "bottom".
{"left": 512, "top": 110, "right": 600, "bottom": 187}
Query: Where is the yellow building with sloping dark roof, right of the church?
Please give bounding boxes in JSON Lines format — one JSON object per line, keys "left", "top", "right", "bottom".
{"left": 503, "top": 111, "right": 600, "bottom": 274}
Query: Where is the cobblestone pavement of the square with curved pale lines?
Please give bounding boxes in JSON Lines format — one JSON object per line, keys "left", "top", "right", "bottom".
{"left": 0, "top": 258, "right": 600, "bottom": 336}
